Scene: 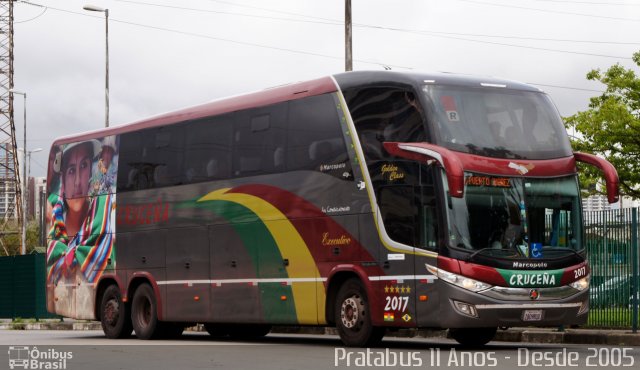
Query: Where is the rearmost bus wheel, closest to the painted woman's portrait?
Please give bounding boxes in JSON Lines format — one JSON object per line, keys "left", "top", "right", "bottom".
{"left": 100, "top": 285, "right": 133, "bottom": 339}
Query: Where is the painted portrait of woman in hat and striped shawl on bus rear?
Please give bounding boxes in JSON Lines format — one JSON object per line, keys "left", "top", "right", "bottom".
{"left": 47, "top": 137, "right": 117, "bottom": 318}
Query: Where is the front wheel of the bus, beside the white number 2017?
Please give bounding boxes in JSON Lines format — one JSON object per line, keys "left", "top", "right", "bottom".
{"left": 334, "top": 279, "right": 384, "bottom": 347}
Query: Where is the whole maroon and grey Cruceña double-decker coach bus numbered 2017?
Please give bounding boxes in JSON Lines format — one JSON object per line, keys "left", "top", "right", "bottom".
{"left": 47, "top": 71, "right": 618, "bottom": 346}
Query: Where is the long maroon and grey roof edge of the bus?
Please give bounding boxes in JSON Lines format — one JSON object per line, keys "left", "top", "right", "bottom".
{"left": 53, "top": 71, "right": 540, "bottom": 145}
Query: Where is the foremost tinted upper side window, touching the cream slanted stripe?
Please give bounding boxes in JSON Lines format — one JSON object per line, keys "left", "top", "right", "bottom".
{"left": 286, "top": 94, "right": 353, "bottom": 180}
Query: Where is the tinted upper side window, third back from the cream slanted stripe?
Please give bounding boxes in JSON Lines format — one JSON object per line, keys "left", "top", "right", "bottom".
{"left": 184, "top": 114, "right": 233, "bottom": 183}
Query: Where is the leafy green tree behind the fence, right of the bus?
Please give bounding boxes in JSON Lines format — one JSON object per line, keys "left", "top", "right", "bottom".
{"left": 565, "top": 51, "right": 640, "bottom": 198}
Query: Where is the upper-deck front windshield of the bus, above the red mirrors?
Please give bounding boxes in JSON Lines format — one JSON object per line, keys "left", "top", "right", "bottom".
{"left": 423, "top": 85, "right": 572, "bottom": 159}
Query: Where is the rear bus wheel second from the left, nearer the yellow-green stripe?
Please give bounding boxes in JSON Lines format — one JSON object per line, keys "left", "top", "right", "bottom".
{"left": 131, "top": 284, "right": 162, "bottom": 339}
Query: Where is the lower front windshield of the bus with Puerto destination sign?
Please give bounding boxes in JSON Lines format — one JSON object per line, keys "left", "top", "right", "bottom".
{"left": 449, "top": 173, "right": 584, "bottom": 259}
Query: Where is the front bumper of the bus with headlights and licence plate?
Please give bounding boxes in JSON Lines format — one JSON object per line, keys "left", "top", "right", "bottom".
{"left": 439, "top": 282, "right": 589, "bottom": 328}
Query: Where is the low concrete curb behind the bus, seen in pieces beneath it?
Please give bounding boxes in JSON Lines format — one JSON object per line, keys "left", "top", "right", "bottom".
{"left": 0, "top": 321, "right": 640, "bottom": 346}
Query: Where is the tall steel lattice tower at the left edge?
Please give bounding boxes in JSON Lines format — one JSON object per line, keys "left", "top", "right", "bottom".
{"left": 0, "top": 0, "right": 26, "bottom": 254}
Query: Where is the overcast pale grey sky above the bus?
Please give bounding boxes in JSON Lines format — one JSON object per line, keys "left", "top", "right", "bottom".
{"left": 14, "top": 0, "right": 640, "bottom": 176}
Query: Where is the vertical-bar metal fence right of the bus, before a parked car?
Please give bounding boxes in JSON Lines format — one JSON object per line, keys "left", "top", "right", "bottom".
{"left": 584, "top": 208, "right": 640, "bottom": 331}
